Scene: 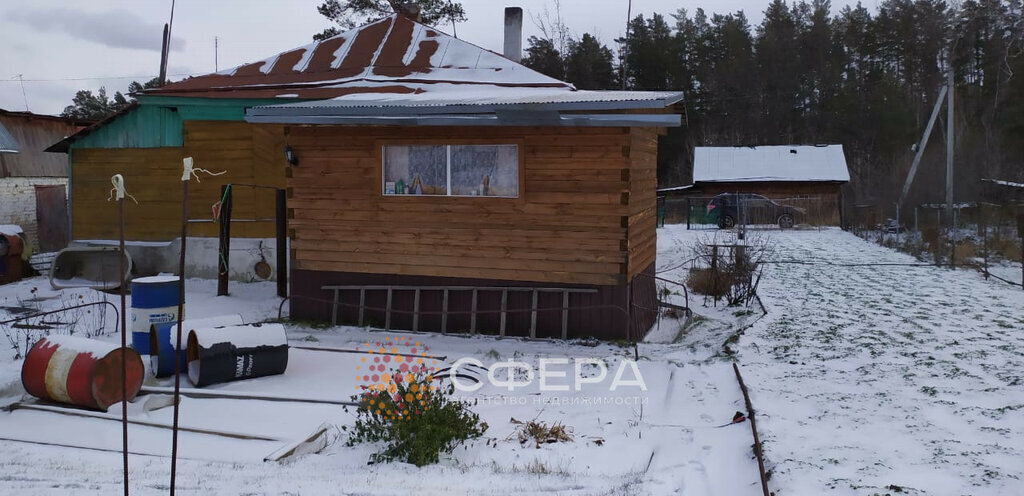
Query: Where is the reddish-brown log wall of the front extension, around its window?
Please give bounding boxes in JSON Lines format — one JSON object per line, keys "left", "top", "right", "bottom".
{"left": 286, "top": 126, "right": 656, "bottom": 286}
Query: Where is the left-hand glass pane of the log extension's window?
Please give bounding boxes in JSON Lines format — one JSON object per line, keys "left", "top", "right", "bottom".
{"left": 384, "top": 146, "right": 447, "bottom": 195}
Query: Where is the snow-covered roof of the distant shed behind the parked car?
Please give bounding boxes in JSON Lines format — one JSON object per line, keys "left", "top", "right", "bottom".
{"left": 693, "top": 144, "right": 850, "bottom": 182}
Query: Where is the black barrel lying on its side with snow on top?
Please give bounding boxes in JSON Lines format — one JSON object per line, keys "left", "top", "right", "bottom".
{"left": 186, "top": 324, "right": 288, "bottom": 387}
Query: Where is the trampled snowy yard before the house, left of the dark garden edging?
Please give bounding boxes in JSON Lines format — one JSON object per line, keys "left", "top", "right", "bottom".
{"left": 0, "top": 279, "right": 759, "bottom": 495}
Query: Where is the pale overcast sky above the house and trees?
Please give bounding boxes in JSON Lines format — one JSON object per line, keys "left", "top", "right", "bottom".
{"left": 0, "top": 0, "right": 879, "bottom": 114}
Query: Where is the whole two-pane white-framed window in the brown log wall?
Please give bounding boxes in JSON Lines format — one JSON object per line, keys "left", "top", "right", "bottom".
{"left": 382, "top": 144, "right": 519, "bottom": 198}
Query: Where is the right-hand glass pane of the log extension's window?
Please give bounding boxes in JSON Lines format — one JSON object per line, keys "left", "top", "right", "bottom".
{"left": 452, "top": 144, "right": 519, "bottom": 198}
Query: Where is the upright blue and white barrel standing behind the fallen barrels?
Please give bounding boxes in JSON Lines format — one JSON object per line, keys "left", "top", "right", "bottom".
{"left": 131, "top": 276, "right": 178, "bottom": 362}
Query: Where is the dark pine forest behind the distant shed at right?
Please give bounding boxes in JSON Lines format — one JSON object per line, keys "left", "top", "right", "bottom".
{"left": 524, "top": 0, "right": 1024, "bottom": 205}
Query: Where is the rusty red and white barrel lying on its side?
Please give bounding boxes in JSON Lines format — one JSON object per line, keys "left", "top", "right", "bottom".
{"left": 22, "top": 336, "right": 145, "bottom": 411}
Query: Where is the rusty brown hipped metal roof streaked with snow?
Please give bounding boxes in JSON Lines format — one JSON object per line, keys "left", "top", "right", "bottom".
{"left": 143, "top": 14, "right": 572, "bottom": 99}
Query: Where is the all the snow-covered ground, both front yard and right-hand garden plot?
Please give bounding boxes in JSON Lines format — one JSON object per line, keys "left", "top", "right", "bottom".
{"left": 0, "top": 226, "right": 1024, "bottom": 496}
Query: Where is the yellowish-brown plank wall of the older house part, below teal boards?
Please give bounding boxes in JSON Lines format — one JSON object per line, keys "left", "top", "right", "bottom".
{"left": 72, "top": 121, "right": 288, "bottom": 241}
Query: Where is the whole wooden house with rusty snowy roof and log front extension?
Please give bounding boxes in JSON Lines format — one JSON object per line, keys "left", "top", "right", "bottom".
{"left": 49, "top": 15, "right": 682, "bottom": 339}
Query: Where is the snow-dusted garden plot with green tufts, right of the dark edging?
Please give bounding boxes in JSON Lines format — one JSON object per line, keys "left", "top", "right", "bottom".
{"left": 667, "top": 230, "right": 1024, "bottom": 495}
